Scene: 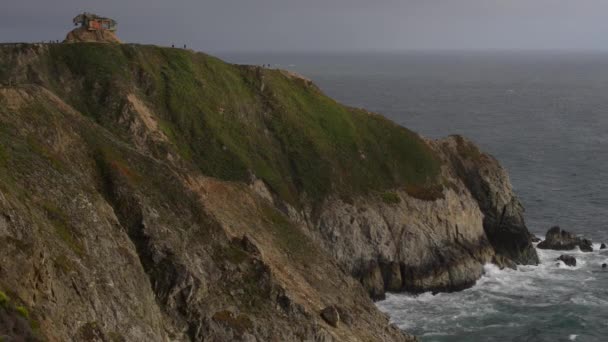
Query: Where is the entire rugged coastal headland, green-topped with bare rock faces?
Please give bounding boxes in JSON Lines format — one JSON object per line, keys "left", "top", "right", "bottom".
{"left": 0, "top": 43, "right": 538, "bottom": 341}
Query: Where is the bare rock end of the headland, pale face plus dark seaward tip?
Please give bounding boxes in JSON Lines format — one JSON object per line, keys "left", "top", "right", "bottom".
{"left": 289, "top": 137, "right": 538, "bottom": 299}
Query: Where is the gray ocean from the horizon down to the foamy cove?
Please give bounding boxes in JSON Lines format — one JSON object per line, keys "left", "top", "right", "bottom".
{"left": 222, "top": 52, "right": 608, "bottom": 341}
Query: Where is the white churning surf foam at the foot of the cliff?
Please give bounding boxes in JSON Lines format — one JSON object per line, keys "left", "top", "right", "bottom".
{"left": 378, "top": 244, "right": 608, "bottom": 337}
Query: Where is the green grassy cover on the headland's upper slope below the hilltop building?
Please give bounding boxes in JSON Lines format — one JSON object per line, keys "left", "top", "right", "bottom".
{"left": 14, "top": 44, "right": 440, "bottom": 205}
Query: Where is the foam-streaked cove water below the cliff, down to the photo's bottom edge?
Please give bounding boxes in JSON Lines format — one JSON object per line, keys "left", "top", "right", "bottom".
{"left": 378, "top": 245, "right": 608, "bottom": 341}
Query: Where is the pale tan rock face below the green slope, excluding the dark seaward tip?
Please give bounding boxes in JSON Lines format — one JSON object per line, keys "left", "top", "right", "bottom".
{"left": 307, "top": 174, "right": 494, "bottom": 299}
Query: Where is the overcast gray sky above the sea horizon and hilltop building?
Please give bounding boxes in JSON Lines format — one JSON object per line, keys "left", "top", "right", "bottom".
{"left": 0, "top": 0, "right": 608, "bottom": 52}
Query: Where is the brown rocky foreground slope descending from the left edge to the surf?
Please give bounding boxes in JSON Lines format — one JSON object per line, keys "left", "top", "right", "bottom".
{"left": 0, "top": 86, "right": 413, "bottom": 341}
